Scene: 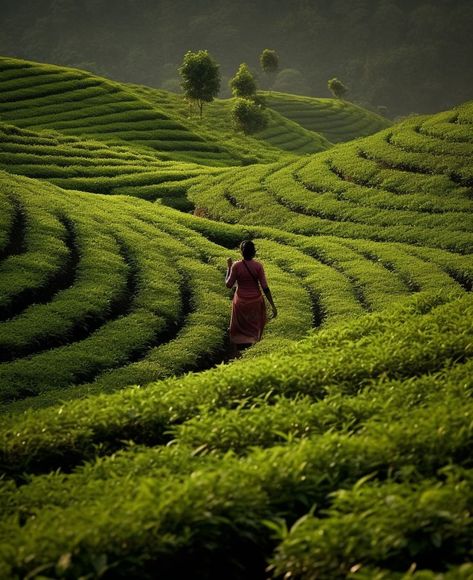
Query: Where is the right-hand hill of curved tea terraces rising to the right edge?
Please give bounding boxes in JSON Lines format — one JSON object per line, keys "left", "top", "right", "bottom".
{"left": 189, "top": 103, "right": 473, "bottom": 253}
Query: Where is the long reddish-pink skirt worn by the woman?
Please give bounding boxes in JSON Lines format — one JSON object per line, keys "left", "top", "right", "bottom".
{"left": 230, "top": 292, "right": 266, "bottom": 344}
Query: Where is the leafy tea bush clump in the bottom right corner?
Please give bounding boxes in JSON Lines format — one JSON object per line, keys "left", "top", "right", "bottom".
{"left": 273, "top": 468, "right": 473, "bottom": 580}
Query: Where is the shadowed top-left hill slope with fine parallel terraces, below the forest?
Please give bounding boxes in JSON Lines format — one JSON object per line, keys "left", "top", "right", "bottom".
{"left": 0, "top": 58, "right": 239, "bottom": 165}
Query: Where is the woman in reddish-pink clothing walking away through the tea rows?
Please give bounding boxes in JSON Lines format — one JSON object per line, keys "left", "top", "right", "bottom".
{"left": 225, "top": 241, "right": 278, "bottom": 356}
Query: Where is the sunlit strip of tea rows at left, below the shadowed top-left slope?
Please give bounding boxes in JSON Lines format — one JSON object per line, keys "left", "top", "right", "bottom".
{"left": 0, "top": 122, "right": 220, "bottom": 210}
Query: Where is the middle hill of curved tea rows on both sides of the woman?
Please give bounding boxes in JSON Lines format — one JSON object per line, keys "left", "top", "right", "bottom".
{"left": 0, "top": 165, "right": 473, "bottom": 412}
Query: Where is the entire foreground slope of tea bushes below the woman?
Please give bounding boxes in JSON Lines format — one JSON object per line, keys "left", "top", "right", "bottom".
{"left": 0, "top": 294, "right": 473, "bottom": 578}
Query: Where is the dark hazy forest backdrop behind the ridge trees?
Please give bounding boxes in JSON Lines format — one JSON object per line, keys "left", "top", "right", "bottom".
{"left": 0, "top": 0, "right": 473, "bottom": 118}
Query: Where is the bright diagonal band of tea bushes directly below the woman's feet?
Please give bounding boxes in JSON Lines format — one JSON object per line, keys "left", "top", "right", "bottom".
{"left": 2, "top": 295, "right": 472, "bottom": 472}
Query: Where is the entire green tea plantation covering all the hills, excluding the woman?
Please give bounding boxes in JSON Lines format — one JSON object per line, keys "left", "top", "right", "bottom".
{"left": 0, "top": 58, "right": 473, "bottom": 580}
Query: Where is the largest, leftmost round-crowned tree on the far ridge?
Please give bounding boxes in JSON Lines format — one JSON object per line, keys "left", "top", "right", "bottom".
{"left": 179, "top": 50, "right": 220, "bottom": 118}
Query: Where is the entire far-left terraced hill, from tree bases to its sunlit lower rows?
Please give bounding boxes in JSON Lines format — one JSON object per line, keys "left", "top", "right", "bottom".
{"left": 0, "top": 58, "right": 390, "bottom": 210}
